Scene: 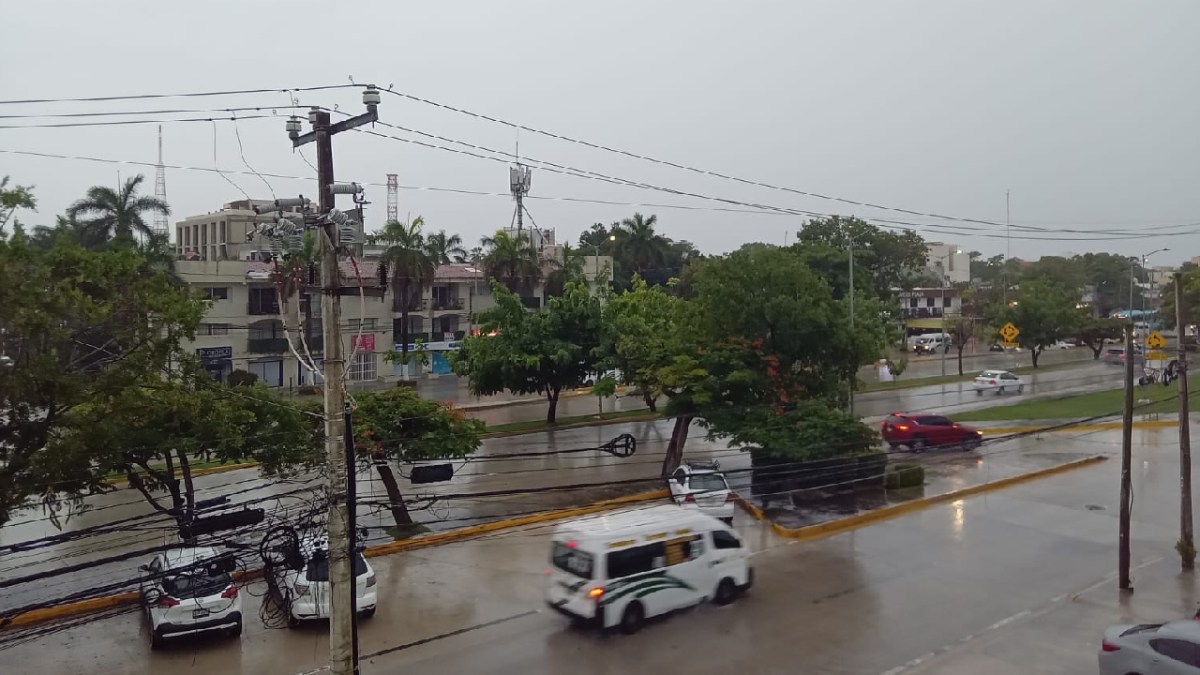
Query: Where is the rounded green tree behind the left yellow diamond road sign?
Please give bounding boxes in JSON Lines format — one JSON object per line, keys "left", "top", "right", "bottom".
{"left": 992, "top": 280, "right": 1081, "bottom": 368}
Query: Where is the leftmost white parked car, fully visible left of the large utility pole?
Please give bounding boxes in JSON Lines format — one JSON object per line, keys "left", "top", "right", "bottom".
{"left": 139, "top": 546, "right": 241, "bottom": 649}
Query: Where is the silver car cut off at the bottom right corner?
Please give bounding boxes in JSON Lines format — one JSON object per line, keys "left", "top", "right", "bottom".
{"left": 1099, "top": 620, "right": 1200, "bottom": 675}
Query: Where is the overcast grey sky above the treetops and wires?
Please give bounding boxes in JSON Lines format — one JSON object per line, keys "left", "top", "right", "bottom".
{"left": 0, "top": 0, "right": 1200, "bottom": 264}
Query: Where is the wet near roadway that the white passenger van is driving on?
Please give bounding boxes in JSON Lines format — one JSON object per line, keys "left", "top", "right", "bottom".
{"left": 0, "top": 429, "right": 1196, "bottom": 675}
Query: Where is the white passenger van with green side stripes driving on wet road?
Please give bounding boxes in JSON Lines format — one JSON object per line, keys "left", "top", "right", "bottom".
{"left": 546, "top": 506, "right": 754, "bottom": 634}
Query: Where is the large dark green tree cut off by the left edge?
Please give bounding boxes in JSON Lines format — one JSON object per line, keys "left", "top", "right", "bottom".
{"left": 0, "top": 228, "right": 205, "bottom": 522}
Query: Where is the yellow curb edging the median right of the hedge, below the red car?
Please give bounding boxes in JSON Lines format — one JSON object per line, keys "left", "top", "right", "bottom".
{"left": 737, "top": 455, "right": 1108, "bottom": 542}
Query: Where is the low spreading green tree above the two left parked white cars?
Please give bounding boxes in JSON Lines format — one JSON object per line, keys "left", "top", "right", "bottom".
{"left": 41, "top": 366, "right": 319, "bottom": 524}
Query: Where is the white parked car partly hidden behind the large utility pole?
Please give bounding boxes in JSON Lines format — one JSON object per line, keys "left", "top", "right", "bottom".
{"left": 270, "top": 537, "right": 378, "bottom": 626}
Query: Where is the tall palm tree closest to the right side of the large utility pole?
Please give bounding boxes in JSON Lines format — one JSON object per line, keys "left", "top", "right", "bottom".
{"left": 372, "top": 216, "right": 438, "bottom": 374}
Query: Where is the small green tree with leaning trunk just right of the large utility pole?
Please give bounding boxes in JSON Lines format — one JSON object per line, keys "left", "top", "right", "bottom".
{"left": 354, "top": 387, "right": 484, "bottom": 527}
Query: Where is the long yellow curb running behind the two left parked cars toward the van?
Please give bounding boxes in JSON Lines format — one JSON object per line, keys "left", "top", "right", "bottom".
{"left": 0, "top": 485, "right": 670, "bottom": 633}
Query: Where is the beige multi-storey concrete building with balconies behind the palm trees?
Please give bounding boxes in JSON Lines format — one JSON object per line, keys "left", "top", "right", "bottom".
{"left": 175, "top": 201, "right": 612, "bottom": 388}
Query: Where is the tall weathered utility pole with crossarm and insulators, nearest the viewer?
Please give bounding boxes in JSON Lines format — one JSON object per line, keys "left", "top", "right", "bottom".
{"left": 287, "top": 85, "right": 379, "bottom": 675}
